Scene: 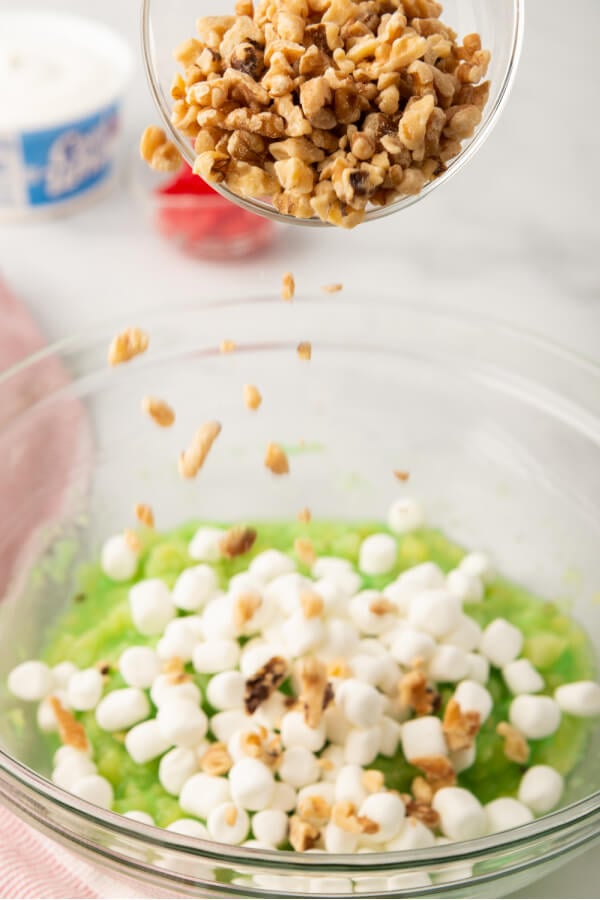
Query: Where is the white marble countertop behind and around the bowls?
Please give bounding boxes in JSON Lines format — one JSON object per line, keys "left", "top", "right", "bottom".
{"left": 0, "top": 0, "right": 600, "bottom": 897}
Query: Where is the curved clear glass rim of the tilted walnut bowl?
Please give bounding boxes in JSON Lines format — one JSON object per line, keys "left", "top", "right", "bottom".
{"left": 141, "top": 0, "right": 525, "bottom": 228}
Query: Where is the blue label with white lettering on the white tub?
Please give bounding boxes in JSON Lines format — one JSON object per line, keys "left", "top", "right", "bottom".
{"left": 21, "top": 105, "right": 118, "bottom": 206}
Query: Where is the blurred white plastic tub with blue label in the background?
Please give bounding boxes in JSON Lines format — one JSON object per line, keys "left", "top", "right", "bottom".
{"left": 0, "top": 10, "right": 132, "bottom": 220}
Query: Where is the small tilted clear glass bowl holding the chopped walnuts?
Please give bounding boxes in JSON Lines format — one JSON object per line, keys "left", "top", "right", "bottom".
{"left": 142, "top": 0, "right": 524, "bottom": 226}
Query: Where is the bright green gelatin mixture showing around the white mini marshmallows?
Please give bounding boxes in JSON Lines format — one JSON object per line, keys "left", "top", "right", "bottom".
{"left": 43, "top": 522, "right": 594, "bottom": 826}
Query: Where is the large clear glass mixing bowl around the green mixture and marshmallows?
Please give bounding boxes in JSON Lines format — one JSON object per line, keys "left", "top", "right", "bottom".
{"left": 0, "top": 291, "right": 600, "bottom": 897}
